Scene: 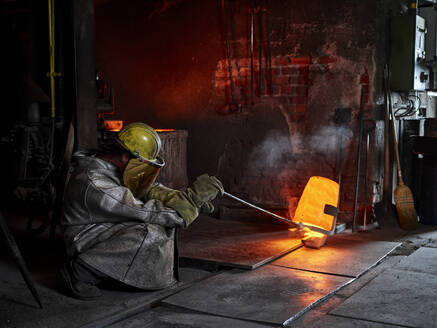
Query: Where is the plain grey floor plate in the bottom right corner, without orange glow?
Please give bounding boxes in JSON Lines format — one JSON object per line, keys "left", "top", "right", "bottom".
{"left": 330, "top": 269, "right": 437, "bottom": 328}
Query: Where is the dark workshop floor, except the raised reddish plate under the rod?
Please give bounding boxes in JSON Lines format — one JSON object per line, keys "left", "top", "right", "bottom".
{"left": 0, "top": 211, "right": 437, "bottom": 328}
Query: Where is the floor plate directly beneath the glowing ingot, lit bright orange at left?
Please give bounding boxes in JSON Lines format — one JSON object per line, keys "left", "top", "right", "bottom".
{"left": 272, "top": 236, "right": 400, "bottom": 277}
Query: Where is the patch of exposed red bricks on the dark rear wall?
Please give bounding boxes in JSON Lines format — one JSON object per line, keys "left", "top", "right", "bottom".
{"left": 212, "top": 55, "right": 338, "bottom": 121}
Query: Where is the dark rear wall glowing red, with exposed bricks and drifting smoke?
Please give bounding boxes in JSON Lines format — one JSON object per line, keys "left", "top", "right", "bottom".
{"left": 95, "top": 1, "right": 378, "bottom": 219}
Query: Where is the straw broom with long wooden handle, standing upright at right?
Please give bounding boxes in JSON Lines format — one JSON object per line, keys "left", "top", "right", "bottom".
{"left": 388, "top": 90, "right": 417, "bottom": 230}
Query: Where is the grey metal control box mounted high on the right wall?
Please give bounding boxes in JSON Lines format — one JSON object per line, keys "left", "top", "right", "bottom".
{"left": 390, "top": 15, "right": 430, "bottom": 92}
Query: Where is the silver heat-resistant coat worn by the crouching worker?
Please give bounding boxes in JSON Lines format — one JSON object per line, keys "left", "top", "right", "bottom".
{"left": 62, "top": 151, "right": 185, "bottom": 289}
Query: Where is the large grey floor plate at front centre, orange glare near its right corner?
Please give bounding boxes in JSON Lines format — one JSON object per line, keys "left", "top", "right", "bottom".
{"left": 163, "top": 265, "right": 349, "bottom": 324}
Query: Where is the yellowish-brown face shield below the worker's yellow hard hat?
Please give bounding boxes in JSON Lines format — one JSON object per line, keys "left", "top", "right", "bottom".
{"left": 123, "top": 158, "right": 161, "bottom": 199}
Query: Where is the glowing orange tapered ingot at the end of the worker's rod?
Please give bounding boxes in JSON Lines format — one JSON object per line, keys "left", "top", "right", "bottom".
{"left": 293, "top": 177, "right": 340, "bottom": 231}
